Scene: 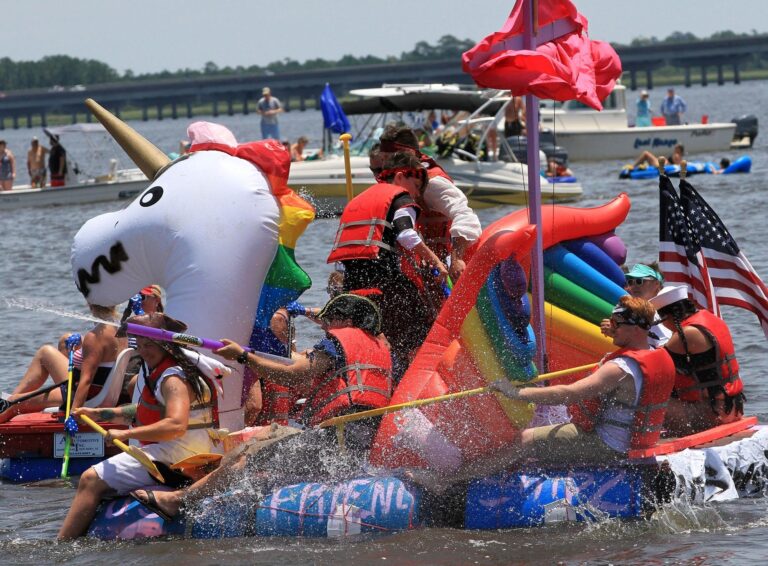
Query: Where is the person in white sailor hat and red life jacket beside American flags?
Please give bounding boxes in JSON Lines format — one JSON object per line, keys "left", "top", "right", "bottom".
{"left": 651, "top": 286, "right": 746, "bottom": 435}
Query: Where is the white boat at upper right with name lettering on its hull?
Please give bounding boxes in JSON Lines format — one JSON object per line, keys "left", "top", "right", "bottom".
{"left": 541, "top": 85, "right": 736, "bottom": 161}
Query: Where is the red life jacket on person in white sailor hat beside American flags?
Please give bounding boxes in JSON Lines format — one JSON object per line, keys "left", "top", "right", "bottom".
{"left": 675, "top": 310, "right": 744, "bottom": 403}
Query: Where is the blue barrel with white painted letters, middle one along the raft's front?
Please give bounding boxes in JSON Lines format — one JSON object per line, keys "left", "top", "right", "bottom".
{"left": 255, "top": 477, "right": 420, "bottom": 537}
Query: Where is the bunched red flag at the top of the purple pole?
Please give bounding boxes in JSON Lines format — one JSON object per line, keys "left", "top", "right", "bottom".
{"left": 462, "top": 0, "right": 621, "bottom": 110}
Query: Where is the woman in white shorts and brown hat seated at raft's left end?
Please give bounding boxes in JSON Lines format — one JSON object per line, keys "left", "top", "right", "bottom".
{"left": 58, "top": 313, "right": 228, "bottom": 540}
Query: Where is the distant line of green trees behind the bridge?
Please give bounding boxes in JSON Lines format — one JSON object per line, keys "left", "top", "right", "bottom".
{"left": 0, "top": 30, "right": 765, "bottom": 91}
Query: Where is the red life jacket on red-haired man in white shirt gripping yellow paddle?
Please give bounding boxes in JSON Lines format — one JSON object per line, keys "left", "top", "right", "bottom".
{"left": 568, "top": 348, "right": 675, "bottom": 449}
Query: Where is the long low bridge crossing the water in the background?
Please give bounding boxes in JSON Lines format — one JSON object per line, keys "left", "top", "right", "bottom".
{"left": 0, "top": 36, "right": 768, "bottom": 129}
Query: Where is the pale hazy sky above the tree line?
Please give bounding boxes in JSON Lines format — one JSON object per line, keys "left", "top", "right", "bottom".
{"left": 0, "top": 0, "right": 768, "bottom": 73}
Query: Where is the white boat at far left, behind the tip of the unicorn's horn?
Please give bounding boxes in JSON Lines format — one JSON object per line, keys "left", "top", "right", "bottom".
{"left": 0, "top": 124, "right": 147, "bottom": 210}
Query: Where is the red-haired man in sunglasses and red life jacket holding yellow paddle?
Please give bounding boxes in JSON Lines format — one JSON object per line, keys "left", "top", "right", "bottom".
{"left": 472, "top": 295, "right": 675, "bottom": 474}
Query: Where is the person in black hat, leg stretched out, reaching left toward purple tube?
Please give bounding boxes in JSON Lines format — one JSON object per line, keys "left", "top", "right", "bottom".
{"left": 132, "top": 294, "right": 392, "bottom": 517}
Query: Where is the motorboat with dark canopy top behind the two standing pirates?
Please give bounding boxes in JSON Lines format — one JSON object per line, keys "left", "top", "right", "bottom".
{"left": 288, "top": 85, "right": 582, "bottom": 212}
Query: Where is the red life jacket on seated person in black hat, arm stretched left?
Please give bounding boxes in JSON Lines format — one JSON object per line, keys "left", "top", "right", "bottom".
{"left": 302, "top": 327, "right": 392, "bottom": 425}
